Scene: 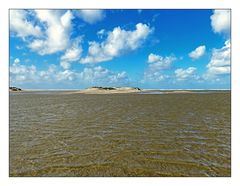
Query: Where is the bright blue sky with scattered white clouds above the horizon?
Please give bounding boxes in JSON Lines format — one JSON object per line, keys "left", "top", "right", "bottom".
{"left": 9, "top": 9, "right": 231, "bottom": 89}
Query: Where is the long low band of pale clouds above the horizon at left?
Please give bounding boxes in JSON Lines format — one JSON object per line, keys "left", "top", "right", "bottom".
{"left": 10, "top": 62, "right": 129, "bottom": 86}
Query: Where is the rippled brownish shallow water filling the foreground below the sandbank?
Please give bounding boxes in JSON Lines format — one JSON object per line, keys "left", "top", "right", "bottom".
{"left": 9, "top": 92, "right": 231, "bottom": 176}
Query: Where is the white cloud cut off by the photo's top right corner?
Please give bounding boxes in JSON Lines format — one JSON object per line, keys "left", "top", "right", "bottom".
{"left": 210, "top": 10, "right": 231, "bottom": 33}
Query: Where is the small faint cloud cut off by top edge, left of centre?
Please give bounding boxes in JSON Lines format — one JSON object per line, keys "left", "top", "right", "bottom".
{"left": 79, "top": 10, "right": 105, "bottom": 24}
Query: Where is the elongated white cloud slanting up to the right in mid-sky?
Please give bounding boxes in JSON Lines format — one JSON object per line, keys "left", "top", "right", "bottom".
{"left": 80, "top": 23, "right": 152, "bottom": 64}
